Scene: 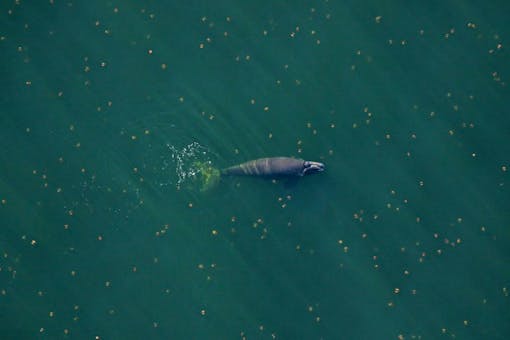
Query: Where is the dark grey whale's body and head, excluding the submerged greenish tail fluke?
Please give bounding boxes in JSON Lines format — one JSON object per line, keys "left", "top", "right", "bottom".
{"left": 221, "top": 157, "right": 324, "bottom": 177}
